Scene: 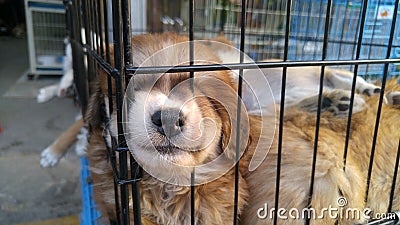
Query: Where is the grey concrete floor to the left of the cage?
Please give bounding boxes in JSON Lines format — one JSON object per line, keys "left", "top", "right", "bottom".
{"left": 0, "top": 37, "right": 81, "bottom": 225}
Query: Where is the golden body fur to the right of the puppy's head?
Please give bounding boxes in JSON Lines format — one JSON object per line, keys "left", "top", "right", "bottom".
{"left": 241, "top": 80, "right": 400, "bottom": 224}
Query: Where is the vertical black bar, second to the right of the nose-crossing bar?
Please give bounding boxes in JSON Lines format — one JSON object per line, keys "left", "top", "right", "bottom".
{"left": 274, "top": 0, "right": 292, "bottom": 225}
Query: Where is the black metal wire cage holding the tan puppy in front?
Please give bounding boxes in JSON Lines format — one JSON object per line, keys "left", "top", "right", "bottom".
{"left": 64, "top": 0, "right": 400, "bottom": 224}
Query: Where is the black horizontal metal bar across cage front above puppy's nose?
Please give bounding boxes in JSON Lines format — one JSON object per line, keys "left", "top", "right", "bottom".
{"left": 126, "top": 58, "right": 400, "bottom": 74}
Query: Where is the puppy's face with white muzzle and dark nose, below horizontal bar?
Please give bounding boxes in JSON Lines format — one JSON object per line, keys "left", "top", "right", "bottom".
{"left": 128, "top": 74, "right": 226, "bottom": 166}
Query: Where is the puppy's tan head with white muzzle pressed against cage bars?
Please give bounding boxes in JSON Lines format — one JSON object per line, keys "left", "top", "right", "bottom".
{"left": 125, "top": 35, "right": 248, "bottom": 185}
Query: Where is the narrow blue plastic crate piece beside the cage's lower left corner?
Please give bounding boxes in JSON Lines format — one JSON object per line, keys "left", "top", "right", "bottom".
{"left": 79, "top": 157, "right": 101, "bottom": 225}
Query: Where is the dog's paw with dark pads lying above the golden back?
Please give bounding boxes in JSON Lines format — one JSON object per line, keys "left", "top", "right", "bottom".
{"left": 322, "top": 90, "right": 366, "bottom": 116}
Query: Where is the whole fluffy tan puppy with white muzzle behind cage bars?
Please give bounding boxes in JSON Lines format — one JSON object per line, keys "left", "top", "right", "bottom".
{"left": 86, "top": 34, "right": 400, "bottom": 225}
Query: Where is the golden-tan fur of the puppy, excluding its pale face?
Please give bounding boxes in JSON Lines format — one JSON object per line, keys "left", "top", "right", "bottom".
{"left": 86, "top": 34, "right": 400, "bottom": 225}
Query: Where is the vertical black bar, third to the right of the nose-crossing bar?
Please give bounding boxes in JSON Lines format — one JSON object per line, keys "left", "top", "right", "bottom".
{"left": 306, "top": 0, "right": 332, "bottom": 225}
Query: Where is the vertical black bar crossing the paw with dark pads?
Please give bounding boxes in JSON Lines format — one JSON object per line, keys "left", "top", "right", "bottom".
{"left": 343, "top": 0, "right": 368, "bottom": 170}
